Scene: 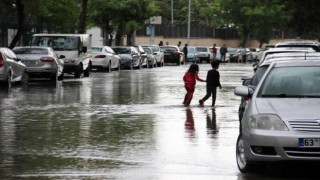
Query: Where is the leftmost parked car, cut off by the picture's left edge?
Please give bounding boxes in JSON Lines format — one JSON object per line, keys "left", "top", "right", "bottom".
{"left": 0, "top": 47, "right": 29, "bottom": 86}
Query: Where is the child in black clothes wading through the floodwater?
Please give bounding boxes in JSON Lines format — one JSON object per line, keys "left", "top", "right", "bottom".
{"left": 199, "top": 61, "right": 222, "bottom": 107}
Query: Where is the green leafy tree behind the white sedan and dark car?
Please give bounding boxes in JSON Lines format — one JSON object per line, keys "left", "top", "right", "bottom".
{"left": 89, "top": 0, "right": 156, "bottom": 45}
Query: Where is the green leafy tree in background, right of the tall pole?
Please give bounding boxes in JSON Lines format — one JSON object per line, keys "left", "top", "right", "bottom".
{"left": 216, "top": 0, "right": 290, "bottom": 46}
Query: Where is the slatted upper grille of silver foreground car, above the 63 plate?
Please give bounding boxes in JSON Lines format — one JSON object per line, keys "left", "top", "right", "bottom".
{"left": 288, "top": 120, "right": 320, "bottom": 132}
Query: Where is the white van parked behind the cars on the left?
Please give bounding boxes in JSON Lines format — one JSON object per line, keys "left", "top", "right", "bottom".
{"left": 31, "top": 34, "right": 92, "bottom": 78}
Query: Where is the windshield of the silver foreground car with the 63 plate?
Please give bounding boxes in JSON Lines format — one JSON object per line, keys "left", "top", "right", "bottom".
{"left": 258, "top": 66, "right": 320, "bottom": 98}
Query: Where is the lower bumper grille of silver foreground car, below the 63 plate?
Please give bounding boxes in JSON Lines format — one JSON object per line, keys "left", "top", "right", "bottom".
{"left": 283, "top": 147, "right": 320, "bottom": 159}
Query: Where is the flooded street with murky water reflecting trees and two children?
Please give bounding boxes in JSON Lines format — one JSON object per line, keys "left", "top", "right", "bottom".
{"left": 0, "top": 64, "right": 318, "bottom": 180}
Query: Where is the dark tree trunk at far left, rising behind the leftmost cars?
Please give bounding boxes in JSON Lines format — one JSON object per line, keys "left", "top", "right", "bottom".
{"left": 9, "top": 0, "right": 24, "bottom": 49}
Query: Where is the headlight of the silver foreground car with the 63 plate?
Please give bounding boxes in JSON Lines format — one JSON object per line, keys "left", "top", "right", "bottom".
{"left": 249, "top": 114, "right": 289, "bottom": 131}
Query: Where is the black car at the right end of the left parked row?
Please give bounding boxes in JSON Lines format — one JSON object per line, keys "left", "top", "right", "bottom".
{"left": 160, "top": 45, "right": 185, "bottom": 66}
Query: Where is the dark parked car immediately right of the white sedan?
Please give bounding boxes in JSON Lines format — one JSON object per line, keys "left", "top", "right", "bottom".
{"left": 112, "top": 46, "right": 142, "bottom": 69}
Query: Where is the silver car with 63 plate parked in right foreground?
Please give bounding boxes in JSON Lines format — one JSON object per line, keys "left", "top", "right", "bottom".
{"left": 234, "top": 58, "right": 320, "bottom": 173}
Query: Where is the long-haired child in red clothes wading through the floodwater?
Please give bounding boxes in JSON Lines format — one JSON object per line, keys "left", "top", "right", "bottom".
{"left": 183, "top": 64, "right": 206, "bottom": 106}
